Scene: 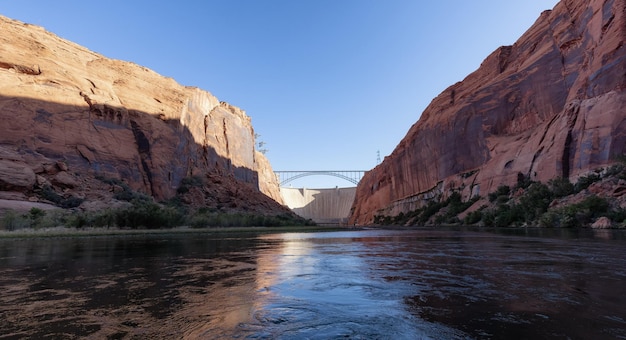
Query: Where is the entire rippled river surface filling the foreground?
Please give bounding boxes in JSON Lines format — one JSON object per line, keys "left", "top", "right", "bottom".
{"left": 0, "top": 230, "right": 626, "bottom": 339}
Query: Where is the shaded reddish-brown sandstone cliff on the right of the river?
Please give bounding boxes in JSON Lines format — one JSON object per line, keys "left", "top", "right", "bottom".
{"left": 351, "top": 0, "right": 626, "bottom": 223}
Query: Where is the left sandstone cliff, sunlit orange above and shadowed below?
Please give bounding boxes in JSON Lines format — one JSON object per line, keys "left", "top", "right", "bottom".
{"left": 0, "top": 16, "right": 283, "bottom": 211}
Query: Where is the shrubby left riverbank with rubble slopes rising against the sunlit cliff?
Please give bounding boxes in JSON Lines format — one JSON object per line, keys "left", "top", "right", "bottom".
{"left": 0, "top": 175, "right": 315, "bottom": 234}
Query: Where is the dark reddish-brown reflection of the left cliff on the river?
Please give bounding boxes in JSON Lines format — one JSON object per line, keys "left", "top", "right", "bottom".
{"left": 0, "top": 235, "right": 256, "bottom": 338}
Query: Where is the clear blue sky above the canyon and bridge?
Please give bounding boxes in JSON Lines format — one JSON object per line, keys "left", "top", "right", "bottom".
{"left": 0, "top": 0, "right": 557, "bottom": 188}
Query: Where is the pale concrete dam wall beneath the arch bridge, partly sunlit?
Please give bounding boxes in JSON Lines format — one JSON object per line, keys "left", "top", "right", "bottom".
{"left": 280, "top": 187, "right": 356, "bottom": 224}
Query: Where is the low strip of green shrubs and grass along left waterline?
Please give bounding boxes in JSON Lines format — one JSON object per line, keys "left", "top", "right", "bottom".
{"left": 0, "top": 199, "right": 320, "bottom": 236}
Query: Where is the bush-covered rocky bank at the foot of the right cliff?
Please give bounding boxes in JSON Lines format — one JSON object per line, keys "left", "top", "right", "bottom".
{"left": 375, "top": 161, "right": 626, "bottom": 229}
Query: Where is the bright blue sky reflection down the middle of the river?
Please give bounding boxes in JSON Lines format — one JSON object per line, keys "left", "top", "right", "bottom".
{"left": 240, "top": 233, "right": 454, "bottom": 339}
